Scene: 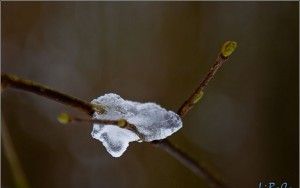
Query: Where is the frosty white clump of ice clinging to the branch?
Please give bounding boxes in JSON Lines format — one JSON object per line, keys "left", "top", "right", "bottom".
{"left": 91, "top": 93, "right": 182, "bottom": 157}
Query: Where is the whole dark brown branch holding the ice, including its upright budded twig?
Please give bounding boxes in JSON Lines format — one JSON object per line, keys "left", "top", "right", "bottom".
{"left": 1, "top": 41, "right": 237, "bottom": 188}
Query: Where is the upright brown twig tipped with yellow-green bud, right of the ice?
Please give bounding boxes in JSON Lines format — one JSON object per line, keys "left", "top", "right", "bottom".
{"left": 177, "top": 41, "right": 237, "bottom": 117}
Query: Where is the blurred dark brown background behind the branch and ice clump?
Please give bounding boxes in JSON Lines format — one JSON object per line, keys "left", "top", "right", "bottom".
{"left": 1, "top": 2, "right": 299, "bottom": 188}
